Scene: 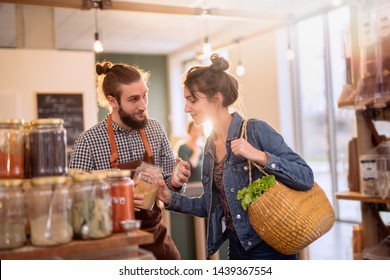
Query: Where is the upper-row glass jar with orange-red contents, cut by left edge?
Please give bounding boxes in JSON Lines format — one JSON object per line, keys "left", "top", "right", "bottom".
{"left": 0, "top": 119, "right": 25, "bottom": 178}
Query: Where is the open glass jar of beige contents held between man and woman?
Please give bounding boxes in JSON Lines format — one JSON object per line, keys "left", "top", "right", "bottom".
{"left": 134, "top": 162, "right": 163, "bottom": 210}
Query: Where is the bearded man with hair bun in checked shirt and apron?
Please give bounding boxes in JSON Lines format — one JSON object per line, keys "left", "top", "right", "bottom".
{"left": 69, "top": 62, "right": 190, "bottom": 259}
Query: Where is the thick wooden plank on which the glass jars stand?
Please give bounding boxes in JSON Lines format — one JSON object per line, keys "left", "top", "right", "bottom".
{"left": 0, "top": 230, "right": 154, "bottom": 260}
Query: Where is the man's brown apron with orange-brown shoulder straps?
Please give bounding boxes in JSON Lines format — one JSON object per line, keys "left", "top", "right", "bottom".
{"left": 107, "top": 114, "right": 180, "bottom": 260}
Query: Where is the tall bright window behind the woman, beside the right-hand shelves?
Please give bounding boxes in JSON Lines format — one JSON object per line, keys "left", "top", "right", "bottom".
{"left": 294, "top": 7, "right": 361, "bottom": 222}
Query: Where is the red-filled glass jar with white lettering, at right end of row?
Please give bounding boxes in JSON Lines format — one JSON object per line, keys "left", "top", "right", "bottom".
{"left": 107, "top": 169, "right": 135, "bottom": 232}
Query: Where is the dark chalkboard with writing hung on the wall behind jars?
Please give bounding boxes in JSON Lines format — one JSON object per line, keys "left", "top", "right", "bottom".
{"left": 37, "top": 93, "right": 84, "bottom": 146}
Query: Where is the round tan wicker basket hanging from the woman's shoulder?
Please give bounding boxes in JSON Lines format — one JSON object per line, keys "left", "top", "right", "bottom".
{"left": 248, "top": 178, "right": 335, "bottom": 255}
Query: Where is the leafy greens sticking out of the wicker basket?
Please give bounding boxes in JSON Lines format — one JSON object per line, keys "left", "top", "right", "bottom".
{"left": 237, "top": 175, "right": 276, "bottom": 210}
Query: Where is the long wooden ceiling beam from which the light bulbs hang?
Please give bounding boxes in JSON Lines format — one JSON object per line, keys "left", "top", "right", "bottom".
{"left": 1, "top": 0, "right": 287, "bottom": 21}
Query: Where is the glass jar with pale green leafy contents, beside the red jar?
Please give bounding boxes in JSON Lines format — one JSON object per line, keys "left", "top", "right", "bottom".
{"left": 71, "top": 173, "right": 112, "bottom": 239}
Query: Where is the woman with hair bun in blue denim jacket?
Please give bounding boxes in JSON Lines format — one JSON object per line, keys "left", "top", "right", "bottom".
{"left": 159, "top": 54, "right": 314, "bottom": 259}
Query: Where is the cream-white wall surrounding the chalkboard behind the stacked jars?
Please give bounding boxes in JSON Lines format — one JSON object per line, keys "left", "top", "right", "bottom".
{"left": 0, "top": 49, "right": 97, "bottom": 129}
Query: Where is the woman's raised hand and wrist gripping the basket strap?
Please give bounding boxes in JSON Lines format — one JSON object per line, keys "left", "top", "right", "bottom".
{"left": 230, "top": 138, "right": 268, "bottom": 166}
